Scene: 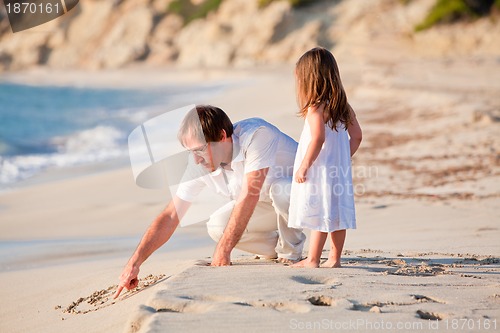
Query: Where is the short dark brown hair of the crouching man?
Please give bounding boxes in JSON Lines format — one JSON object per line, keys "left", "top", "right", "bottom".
{"left": 177, "top": 105, "right": 233, "bottom": 145}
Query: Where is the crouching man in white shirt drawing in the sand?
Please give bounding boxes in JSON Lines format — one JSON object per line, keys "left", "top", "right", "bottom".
{"left": 115, "top": 105, "right": 305, "bottom": 298}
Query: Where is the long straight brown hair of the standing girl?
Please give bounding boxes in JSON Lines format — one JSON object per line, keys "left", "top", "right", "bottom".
{"left": 295, "top": 47, "right": 352, "bottom": 130}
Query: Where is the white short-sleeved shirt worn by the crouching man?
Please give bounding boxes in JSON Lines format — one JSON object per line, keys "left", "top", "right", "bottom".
{"left": 176, "top": 118, "right": 297, "bottom": 202}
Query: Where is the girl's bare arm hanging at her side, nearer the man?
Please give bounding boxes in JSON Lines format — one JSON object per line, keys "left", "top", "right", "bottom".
{"left": 295, "top": 104, "right": 325, "bottom": 183}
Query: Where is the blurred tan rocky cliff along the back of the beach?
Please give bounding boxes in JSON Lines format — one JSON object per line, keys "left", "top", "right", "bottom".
{"left": 0, "top": 0, "right": 500, "bottom": 71}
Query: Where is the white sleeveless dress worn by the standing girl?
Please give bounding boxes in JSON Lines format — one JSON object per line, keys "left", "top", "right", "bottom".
{"left": 288, "top": 120, "right": 356, "bottom": 232}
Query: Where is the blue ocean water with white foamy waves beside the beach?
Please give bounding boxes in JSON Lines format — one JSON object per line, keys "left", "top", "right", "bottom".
{"left": 0, "top": 82, "right": 225, "bottom": 189}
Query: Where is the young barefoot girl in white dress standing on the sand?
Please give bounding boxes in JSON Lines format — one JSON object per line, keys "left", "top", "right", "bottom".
{"left": 288, "top": 48, "right": 361, "bottom": 267}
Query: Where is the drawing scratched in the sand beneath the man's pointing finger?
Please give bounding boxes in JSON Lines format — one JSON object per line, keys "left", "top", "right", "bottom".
{"left": 54, "top": 274, "right": 165, "bottom": 314}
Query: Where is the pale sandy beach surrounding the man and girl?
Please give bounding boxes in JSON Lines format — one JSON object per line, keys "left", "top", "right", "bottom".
{"left": 0, "top": 54, "right": 500, "bottom": 333}
